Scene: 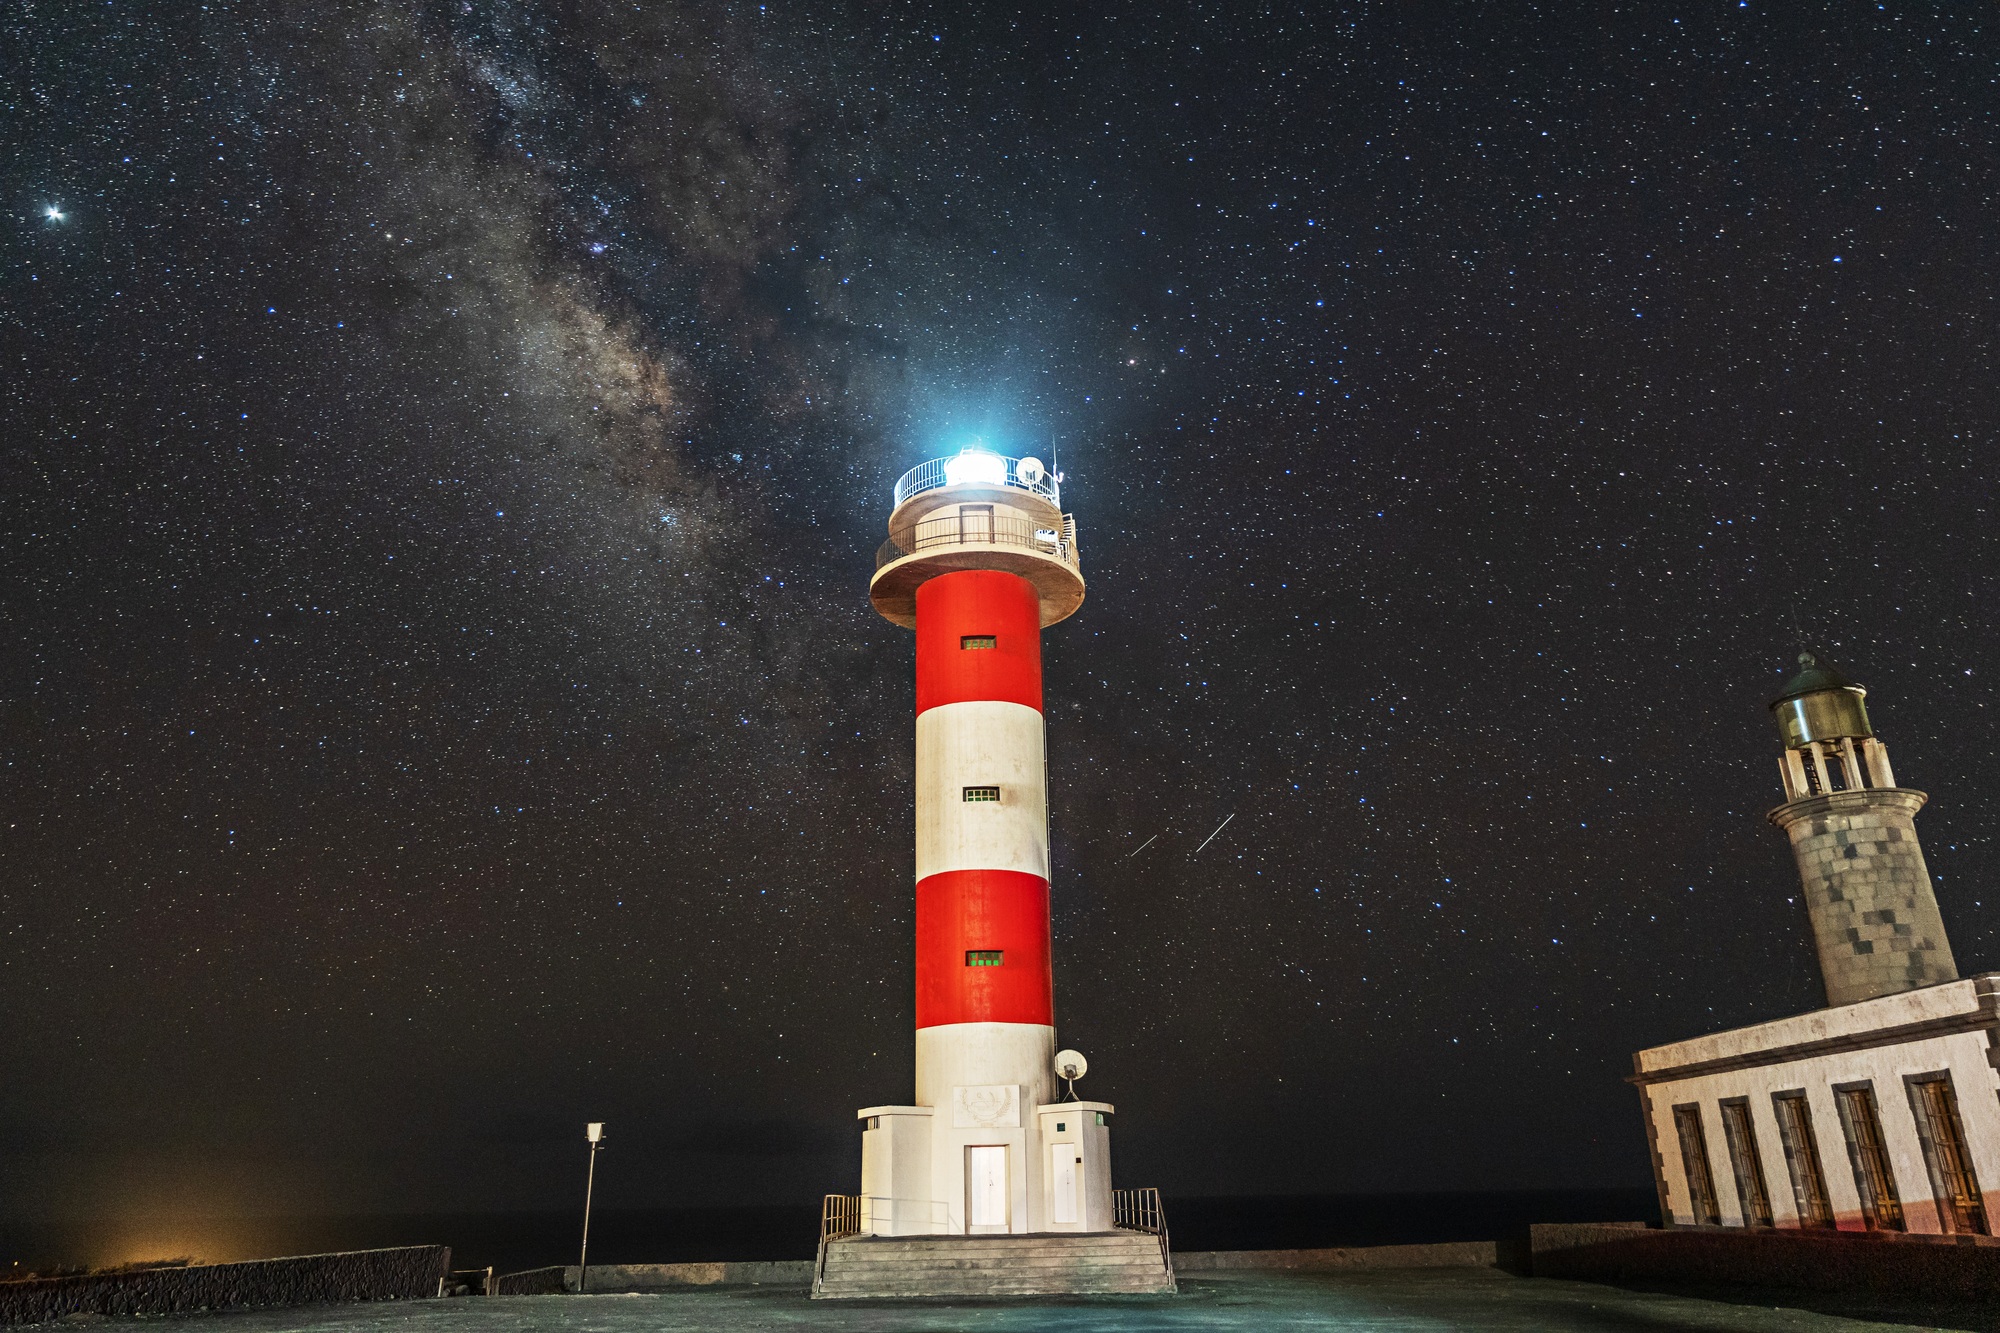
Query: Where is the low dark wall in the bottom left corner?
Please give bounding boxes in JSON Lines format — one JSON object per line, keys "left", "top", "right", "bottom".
{"left": 0, "top": 1245, "right": 452, "bottom": 1323}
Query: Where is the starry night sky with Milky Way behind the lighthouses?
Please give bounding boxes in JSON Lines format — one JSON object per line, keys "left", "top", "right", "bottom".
{"left": 0, "top": 0, "right": 2000, "bottom": 1239}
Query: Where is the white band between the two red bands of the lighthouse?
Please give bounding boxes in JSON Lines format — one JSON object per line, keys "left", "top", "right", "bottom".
{"left": 916, "top": 699, "right": 1048, "bottom": 879}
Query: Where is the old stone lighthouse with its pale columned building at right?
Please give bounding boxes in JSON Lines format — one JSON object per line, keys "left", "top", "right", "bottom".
{"left": 1632, "top": 654, "right": 2000, "bottom": 1235}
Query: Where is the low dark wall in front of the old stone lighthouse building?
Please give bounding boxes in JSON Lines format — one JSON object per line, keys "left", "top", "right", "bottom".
{"left": 1528, "top": 1223, "right": 2000, "bottom": 1301}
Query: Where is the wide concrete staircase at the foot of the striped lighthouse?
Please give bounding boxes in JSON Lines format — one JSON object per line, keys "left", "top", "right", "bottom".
{"left": 812, "top": 1231, "right": 1174, "bottom": 1299}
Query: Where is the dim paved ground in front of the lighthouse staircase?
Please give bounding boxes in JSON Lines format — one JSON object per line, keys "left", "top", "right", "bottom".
{"left": 129, "top": 1269, "right": 1996, "bottom": 1333}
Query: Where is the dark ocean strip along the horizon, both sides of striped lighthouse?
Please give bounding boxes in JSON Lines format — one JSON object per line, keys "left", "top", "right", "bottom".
{"left": 0, "top": 1189, "right": 1658, "bottom": 1273}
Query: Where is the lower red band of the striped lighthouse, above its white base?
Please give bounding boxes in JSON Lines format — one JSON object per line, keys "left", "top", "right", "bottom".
{"left": 916, "top": 871, "right": 1056, "bottom": 1027}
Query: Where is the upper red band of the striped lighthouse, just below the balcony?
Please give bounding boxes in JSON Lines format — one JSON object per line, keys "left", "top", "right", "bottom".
{"left": 916, "top": 568, "right": 1042, "bottom": 713}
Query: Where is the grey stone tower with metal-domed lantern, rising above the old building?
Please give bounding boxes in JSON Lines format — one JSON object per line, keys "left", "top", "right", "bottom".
{"left": 1768, "top": 652, "right": 1958, "bottom": 1005}
